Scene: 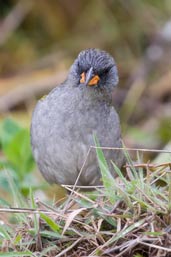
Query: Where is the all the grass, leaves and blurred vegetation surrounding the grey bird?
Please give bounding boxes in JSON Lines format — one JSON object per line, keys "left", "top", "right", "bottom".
{"left": 0, "top": 0, "right": 171, "bottom": 257}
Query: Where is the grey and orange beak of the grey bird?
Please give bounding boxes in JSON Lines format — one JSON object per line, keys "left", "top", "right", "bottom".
{"left": 80, "top": 67, "right": 100, "bottom": 86}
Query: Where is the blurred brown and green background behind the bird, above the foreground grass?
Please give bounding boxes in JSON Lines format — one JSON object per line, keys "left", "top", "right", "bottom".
{"left": 0, "top": 0, "right": 171, "bottom": 201}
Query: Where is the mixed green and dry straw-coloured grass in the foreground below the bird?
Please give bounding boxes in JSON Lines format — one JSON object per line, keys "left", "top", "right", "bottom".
{"left": 0, "top": 147, "right": 171, "bottom": 257}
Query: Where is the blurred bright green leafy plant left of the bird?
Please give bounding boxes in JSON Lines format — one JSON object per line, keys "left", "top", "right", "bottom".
{"left": 0, "top": 119, "right": 35, "bottom": 195}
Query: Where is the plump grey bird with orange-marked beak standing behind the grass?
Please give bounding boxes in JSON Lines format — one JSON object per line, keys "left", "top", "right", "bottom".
{"left": 30, "top": 48, "right": 125, "bottom": 187}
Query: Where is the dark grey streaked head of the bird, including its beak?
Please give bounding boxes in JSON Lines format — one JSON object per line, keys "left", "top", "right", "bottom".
{"left": 69, "top": 48, "right": 118, "bottom": 91}
